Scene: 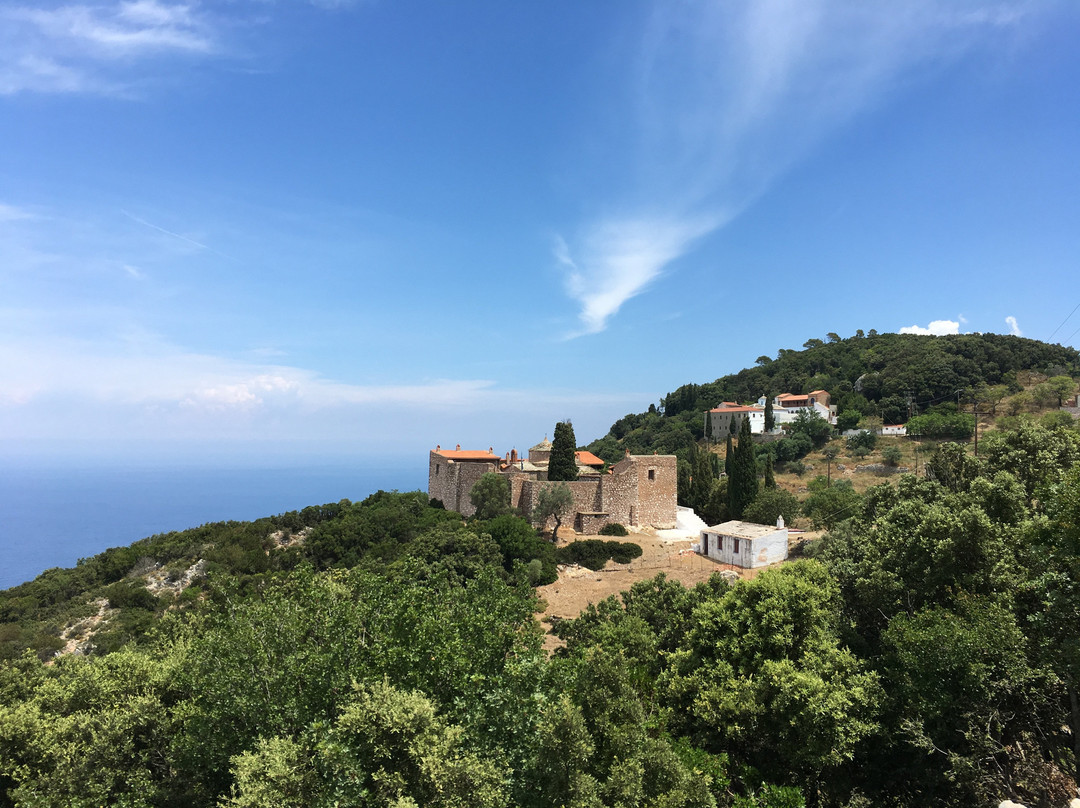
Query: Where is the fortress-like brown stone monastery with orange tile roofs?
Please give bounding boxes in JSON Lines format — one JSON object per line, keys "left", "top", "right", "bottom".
{"left": 428, "top": 439, "right": 677, "bottom": 534}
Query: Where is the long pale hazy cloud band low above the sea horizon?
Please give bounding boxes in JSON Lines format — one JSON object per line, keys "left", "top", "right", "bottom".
{"left": 0, "top": 331, "right": 644, "bottom": 454}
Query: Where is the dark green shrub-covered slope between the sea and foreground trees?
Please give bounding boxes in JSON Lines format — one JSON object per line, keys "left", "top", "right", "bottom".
{"left": 0, "top": 491, "right": 557, "bottom": 660}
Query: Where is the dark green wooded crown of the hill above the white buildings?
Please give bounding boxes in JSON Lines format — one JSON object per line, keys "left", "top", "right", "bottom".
{"left": 589, "top": 331, "right": 1080, "bottom": 461}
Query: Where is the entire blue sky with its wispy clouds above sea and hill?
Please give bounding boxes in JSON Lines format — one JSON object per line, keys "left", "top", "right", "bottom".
{"left": 0, "top": 0, "right": 1080, "bottom": 462}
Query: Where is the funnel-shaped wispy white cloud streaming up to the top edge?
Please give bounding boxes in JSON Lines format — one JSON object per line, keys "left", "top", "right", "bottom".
{"left": 555, "top": 0, "right": 1029, "bottom": 334}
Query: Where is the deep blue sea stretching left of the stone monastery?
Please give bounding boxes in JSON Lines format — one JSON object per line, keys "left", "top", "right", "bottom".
{"left": 0, "top": 461, "right": 428, "bottom": 590}
